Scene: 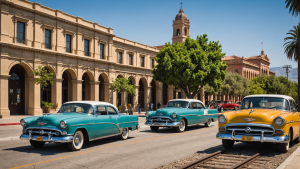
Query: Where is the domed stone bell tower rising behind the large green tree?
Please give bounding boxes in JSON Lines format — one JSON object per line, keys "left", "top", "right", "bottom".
{"left": 172, "top": 6, "right": 190, "bottom": 43}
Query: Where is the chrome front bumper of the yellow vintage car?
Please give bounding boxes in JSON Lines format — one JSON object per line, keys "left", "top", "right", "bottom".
{"left": 216, "top": 133, "right": 289, "bottom": 143}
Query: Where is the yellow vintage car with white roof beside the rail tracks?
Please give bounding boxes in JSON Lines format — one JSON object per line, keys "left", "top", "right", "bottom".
{"left": 217, "top": 94, "right": 300, "bottom": 152}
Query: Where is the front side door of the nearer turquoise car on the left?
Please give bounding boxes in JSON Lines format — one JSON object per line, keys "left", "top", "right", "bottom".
{"left": 95, "top": 105, "right": 111, "bottom": 138}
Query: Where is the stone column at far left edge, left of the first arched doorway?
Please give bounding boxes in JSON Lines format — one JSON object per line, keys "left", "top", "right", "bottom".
{"left": 0, "top": 75, "right": 10, "bottom": 119}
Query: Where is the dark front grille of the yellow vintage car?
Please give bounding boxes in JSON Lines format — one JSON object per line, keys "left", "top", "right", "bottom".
{"left": 226, "top": 123, "right": 275, "bottom": 136}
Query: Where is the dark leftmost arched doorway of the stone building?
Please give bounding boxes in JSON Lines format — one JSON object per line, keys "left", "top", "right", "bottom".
{"left": 8, "top": 65, "right": 26, "bottom": 115}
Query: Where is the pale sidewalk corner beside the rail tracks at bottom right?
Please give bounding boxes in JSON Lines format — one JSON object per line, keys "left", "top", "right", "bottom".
{"left": 277, "top": 147, "right": 300, "bottom": 169}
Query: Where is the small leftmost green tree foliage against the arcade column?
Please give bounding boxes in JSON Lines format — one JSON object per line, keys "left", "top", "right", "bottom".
{"left": 33, "top": 66, "right": 53, "bottom": 91}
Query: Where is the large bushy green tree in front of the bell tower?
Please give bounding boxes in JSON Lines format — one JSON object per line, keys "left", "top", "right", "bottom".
{"left": 152, "top": 34, "right": 227, "bottom": 98}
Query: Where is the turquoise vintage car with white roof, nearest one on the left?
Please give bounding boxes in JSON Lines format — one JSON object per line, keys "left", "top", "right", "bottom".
{"left": 20, "top": 101, "right": 140, "bottom": 150}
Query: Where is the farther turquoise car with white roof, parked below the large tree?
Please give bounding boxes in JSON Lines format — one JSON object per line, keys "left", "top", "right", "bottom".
{"left": 145, "top": 99, "right": 218, "bottom": 132}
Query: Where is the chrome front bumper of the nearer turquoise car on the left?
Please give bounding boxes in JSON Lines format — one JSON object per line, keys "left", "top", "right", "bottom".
{"left": 20, "top": 134, "right": 73, "bottom": 143}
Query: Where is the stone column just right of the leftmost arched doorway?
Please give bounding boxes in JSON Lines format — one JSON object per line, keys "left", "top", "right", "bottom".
{"left": 28, "top": 78, "right": 43, "bottom": 116}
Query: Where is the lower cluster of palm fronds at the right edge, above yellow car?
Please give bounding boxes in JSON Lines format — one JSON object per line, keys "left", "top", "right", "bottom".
{"left": 283, "top": 25, "right": 299, "bottom": 62}
